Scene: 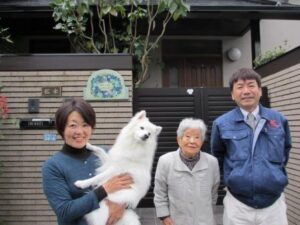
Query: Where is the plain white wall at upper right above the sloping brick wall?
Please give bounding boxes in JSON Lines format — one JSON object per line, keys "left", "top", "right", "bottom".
{"left": 260, "top": 20, "right": 300, "bottom": 54}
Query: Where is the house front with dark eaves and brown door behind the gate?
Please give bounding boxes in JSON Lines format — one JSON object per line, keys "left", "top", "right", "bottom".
{"left": 0, "top": 0, "right": 300, "bottom": 87}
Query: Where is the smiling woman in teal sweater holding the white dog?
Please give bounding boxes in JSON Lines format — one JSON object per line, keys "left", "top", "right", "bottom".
{"left": 42, "top": 99, "right": 133, "bottom": 225}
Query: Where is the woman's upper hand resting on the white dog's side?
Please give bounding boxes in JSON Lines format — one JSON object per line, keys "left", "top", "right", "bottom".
{"left": 102, "top": 174, "right": 133, "bottom": 194}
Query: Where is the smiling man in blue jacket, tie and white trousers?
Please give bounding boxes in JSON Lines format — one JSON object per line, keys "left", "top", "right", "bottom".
{"left": 211, "top": 68, "right": 291, "bottom": 225}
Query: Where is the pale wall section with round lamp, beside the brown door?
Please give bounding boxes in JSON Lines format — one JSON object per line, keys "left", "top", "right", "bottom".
{"left": 223, "top": 31, "right": 252, "bottom": 87}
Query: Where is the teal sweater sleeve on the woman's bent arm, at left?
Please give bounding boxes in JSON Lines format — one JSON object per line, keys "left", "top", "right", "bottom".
{"left": 42, "top": 160, "right": 99, "bottom": 224}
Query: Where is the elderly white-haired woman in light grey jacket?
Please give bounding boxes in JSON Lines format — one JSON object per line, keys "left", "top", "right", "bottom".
{"left": 154, "top": 118, "right": 220, "bottom": 225}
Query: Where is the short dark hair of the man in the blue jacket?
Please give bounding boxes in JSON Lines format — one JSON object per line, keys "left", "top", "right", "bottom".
{"left": 229, "top": 68, "right": 261, "bottom": 91}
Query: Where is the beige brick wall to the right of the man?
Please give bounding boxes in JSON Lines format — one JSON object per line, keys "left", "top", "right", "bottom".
{"left": 263, "top": 63, "right": 300, "bottom": 225}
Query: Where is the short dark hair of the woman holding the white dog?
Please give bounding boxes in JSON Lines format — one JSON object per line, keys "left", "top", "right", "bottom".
{"left": 55, "top": 98, "right": 96, "bottom": 138}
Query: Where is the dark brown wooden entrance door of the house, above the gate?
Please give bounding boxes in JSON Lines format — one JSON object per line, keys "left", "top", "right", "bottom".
{"left": 162, "top": 40, "right": 223, "bottom": 88}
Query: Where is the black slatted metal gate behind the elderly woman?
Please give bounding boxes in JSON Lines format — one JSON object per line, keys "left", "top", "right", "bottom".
{"left": 133, "top": 88, "right": 269, "bottom": 207}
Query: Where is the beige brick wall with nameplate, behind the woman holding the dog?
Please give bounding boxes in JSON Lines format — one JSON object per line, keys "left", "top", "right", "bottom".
{"left": 0, "top": 68, "right": 132, "bottom": 225}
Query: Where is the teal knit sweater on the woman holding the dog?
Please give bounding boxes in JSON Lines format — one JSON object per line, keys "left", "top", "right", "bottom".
{"left": 42, "top": 144, "right": 107, "bottom": 225}
